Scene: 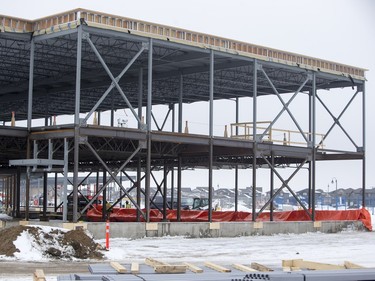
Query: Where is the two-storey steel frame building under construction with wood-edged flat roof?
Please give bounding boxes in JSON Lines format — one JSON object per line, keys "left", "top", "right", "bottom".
{"left": 0, "top": 9, "right": 365, "bottom": 222}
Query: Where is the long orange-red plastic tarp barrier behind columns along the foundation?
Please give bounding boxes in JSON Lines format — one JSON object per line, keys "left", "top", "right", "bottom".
{"left": 87, "top": 205, "right": 372, "bottom": 231}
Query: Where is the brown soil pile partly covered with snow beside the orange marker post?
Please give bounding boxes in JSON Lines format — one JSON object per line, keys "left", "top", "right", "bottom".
{"left": 0, "top": 226, "right": 103, "bottom": 259}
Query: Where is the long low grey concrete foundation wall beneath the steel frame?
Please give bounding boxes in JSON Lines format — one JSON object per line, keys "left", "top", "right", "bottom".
{"left": 2, "top": 221, "right": 365, "bottom": 239}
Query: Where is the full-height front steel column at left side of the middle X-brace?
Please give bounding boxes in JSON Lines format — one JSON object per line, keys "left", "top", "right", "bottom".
{"left": 252, "top": 60, "right": 258, "bottom": 221}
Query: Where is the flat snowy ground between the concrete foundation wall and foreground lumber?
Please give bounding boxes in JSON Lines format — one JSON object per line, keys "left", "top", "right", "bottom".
{"left": 98, "top": 231, "right": 375, "bottom": 268}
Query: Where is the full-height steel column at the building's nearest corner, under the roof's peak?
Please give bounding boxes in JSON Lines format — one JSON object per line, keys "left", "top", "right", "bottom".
{"left": 73, "top": 26, "right": 82, "bottom": 222}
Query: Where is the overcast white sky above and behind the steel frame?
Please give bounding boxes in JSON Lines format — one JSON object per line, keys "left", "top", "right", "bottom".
{"left": 0, "top": 0, "right": 375, "bottom": 192}
